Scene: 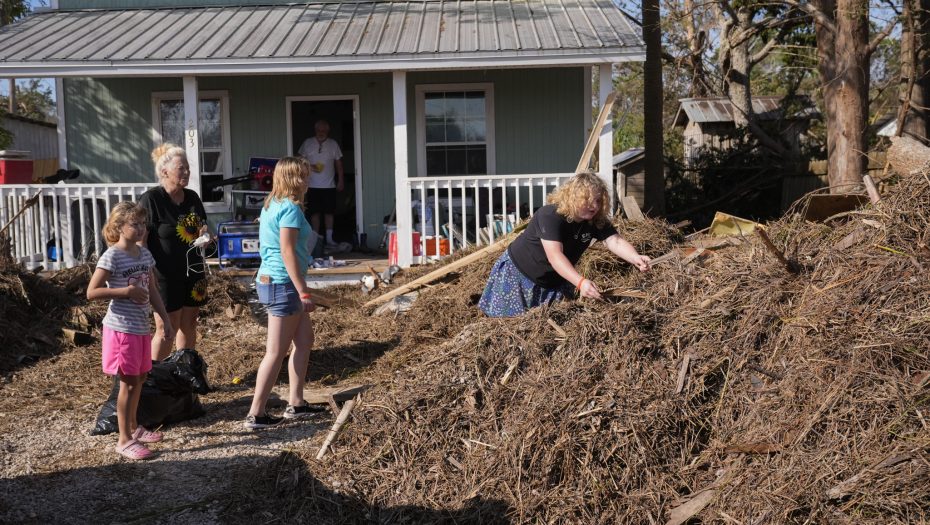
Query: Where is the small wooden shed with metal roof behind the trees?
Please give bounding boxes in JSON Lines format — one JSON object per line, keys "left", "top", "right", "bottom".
{"left": 674, "top": 95, "right": 821, "bottom": 167}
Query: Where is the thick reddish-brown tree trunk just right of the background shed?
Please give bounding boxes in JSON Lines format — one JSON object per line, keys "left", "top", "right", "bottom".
{"left": 814, "top": 0, "right": 871, "bottom": 193}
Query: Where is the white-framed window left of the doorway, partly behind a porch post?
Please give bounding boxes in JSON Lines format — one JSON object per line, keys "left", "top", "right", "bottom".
{"left": 153, "top": 92, "right": 232, "bottom": 209}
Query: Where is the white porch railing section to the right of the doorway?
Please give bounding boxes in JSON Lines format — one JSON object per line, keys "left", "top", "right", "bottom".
{"left": 406, "top": 173, "right": 574, "bottom": 261}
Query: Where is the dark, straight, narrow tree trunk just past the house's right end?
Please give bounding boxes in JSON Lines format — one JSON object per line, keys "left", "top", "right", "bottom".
{"left": 643, "top": 0, "right": 665, "bottom": 217}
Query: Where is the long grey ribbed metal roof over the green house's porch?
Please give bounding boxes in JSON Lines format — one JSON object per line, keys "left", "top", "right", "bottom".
{"left": 0, "top": 0, "right": 645, "bottom": 77}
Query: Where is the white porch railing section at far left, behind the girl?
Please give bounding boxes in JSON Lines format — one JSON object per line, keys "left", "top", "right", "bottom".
{"left": 0, "top": 183, "right": 157, "bottom": 270}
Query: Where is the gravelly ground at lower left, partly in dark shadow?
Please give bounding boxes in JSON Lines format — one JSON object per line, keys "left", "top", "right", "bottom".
{"left": 0, "top": 382, "right": 331, "bottom": 524}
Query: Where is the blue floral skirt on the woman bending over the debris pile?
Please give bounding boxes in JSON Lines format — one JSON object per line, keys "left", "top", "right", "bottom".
{"left": 478, "top": 249, "right": 575, "bottom": 317}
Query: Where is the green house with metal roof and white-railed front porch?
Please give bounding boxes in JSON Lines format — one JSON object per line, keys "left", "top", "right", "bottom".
{"left": 0, "top": 0, "right": 645, "bottom": 266}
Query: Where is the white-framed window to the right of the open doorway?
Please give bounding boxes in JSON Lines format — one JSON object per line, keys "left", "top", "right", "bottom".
{"left": 417, "top": 84, "right": 494, "bottom": 177}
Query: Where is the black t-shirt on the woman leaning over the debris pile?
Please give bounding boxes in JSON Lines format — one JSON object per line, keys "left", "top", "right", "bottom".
{"left": 509, "top": 205, "right": 617, "bottom": 288}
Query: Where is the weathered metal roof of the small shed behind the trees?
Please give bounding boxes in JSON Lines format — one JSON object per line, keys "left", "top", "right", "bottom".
{"left": 675, "top": 95, "right": 820, "bottom": 126}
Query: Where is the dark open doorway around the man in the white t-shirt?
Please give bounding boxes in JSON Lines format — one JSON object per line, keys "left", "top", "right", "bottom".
{"left": 287, "top": 96, "right": 365, "bottom": 246}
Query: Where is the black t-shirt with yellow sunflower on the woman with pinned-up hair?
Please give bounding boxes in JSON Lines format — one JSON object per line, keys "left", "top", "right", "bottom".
{"left": 139, "top": 186, "right": 207, "bottom": 279}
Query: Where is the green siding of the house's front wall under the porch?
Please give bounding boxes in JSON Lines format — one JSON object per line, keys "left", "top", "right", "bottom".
{"left": 64, "top": 68, "right": 585, "bottom": 245}
